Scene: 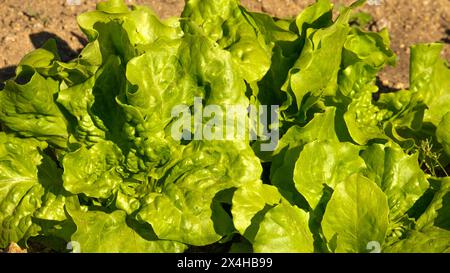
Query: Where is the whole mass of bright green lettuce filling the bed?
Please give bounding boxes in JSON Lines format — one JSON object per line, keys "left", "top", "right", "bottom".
{"left": 0, "top": 0, "right": 450, "bottom": 252}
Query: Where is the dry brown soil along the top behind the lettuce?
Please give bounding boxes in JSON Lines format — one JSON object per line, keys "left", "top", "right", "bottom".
{"left": 0, "top": 0, "right": 450, "bottom": 89}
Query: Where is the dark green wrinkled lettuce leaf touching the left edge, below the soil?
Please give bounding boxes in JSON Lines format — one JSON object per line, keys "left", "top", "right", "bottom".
{"left": 0, "top": 69, "right": 68, "bottom": 147}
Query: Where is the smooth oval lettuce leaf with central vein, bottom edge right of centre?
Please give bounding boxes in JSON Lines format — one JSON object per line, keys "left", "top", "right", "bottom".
{"left": 322, "top": 175, "right": 389, "bottom": 252}
